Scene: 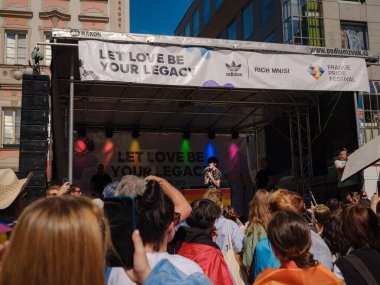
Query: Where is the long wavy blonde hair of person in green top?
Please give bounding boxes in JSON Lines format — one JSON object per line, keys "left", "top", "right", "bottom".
{"left": 247, "top": 189, "right": 271, "bottom": 233}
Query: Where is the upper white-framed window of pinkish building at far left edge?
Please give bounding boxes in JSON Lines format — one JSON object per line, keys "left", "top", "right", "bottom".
{"left": 5, "top": 32, "right": 26, "bottom": 64}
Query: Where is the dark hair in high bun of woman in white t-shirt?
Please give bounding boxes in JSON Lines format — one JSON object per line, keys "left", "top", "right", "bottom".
{"left": 136, "top": 180, "right": 174, "bottom": 251}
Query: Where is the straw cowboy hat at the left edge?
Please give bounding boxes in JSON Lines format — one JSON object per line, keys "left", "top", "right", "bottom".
{"left": 0, "top": 168, "right": 32, "bottom": 210}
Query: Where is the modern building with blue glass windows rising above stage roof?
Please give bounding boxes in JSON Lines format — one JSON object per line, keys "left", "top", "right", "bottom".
{"left": 175, "top": 0, "right": 380, "bottom": 51}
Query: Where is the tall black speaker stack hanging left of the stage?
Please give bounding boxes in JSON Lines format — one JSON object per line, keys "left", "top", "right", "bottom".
{"left": 19, "top": 74, "right": 50, "bottom": 199}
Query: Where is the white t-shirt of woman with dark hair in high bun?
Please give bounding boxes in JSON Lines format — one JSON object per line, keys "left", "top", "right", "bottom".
{"left": 107, "top": 252, "right": 203, "bottom": 285}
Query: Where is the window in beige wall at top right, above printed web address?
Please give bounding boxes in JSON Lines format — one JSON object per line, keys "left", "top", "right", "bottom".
{"left": 341, "top": 22, "right": 368, "bottom": 50}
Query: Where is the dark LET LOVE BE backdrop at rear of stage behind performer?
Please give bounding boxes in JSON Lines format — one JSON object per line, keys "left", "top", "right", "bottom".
{"left": 73, "top": 132, "right": 254, "bottom": 192}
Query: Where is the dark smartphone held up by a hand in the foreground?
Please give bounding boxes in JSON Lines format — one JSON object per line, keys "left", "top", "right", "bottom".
{"left": 104, "top": 196, "right": 136, "bottom": 269}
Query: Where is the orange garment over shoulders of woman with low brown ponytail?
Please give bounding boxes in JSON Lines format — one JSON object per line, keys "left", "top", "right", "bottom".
{"left": 253, "top": 261, "right": 343, "bottom": 285}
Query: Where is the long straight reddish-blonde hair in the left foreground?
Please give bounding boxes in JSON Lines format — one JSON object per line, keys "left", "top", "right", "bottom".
{"left": 0, "top": 196, "right": 109, "bottom": 285}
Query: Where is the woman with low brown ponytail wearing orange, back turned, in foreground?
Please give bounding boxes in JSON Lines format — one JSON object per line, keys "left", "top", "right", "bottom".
{"left": 254, "top": 211, "right": 343, "bottom": 285}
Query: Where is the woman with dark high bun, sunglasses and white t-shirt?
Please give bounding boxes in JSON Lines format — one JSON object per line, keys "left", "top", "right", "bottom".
{"left": 108, "top": 176, "right": 203, "bottom": 285}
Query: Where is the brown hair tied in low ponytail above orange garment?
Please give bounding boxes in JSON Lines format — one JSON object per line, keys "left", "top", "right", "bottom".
{"left": 268, "top": 211, "right": 317, "bottom": 268}
